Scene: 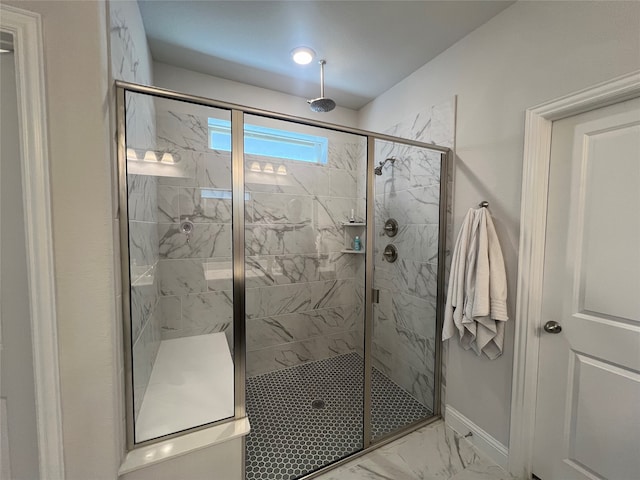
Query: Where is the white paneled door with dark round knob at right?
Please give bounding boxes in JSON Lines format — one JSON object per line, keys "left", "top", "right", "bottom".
{"left": 533, "top": 99, "right": 640, "bottom": 480}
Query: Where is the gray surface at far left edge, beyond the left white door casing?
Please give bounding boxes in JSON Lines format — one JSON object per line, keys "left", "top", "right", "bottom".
{"left": 0, "top": 46, "right": 38, "bottom": 480}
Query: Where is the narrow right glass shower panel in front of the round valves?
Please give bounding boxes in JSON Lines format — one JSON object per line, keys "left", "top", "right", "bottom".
{"left": 371, "top": 140, "right": 441, "bottom": 442}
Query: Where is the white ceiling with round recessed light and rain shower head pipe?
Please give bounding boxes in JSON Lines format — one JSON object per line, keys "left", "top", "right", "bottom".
{"left": 138, "top": 0, "right": 514, "bottom": 110}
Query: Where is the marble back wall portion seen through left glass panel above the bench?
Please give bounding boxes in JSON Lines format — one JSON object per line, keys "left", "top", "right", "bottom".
{"left": 155, "top": 99, "right": 233, "bottom": 349}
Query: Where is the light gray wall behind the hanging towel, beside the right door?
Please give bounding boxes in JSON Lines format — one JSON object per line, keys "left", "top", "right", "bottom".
{"left": 360, "top": 2, "right": 640, "bottom": 445}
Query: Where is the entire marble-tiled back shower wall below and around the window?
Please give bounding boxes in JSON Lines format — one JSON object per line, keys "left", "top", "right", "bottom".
{"left": 150, "top": 106, "right": 365, "bottom": 375}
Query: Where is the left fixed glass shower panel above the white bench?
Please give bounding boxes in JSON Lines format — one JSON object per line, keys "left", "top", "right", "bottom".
{"left": 120, "top": 92, "right": 235, "bottom": 444}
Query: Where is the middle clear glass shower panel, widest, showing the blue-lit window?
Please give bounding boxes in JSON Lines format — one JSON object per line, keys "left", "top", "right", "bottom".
{"left": 244, "top": 115, "right": 366, "bottom": 480}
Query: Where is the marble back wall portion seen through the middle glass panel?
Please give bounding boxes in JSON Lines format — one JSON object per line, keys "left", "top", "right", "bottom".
{"left": 245, "top": 128, "right": 366, "bottom": 376}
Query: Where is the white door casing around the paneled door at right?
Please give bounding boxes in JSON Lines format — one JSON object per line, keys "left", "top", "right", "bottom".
{"left": 509, "top": 70, "right": 640, "bottom": 479}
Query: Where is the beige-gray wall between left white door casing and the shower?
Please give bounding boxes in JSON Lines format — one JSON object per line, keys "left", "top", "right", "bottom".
{"left": 3, "top": 0, "right": 123, "bottom": 480}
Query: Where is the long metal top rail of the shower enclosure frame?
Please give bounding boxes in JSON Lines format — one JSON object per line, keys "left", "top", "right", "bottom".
{"left": 115, "top": 80, "right": 451, "bottom": 154}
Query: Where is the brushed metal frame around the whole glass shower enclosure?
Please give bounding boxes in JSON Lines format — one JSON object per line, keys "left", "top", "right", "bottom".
{"left": 115, "top": 81, "right": 452, "bottom": 464}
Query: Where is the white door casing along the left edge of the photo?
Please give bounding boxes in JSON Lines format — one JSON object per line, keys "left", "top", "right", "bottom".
{"left": 0, "top": 4, "right": 64, "bottom": 480}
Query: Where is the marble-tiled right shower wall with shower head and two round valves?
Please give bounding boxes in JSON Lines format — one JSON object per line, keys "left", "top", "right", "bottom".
{"left": 373, "top": 98, "right": 455, "bottom": 408}
